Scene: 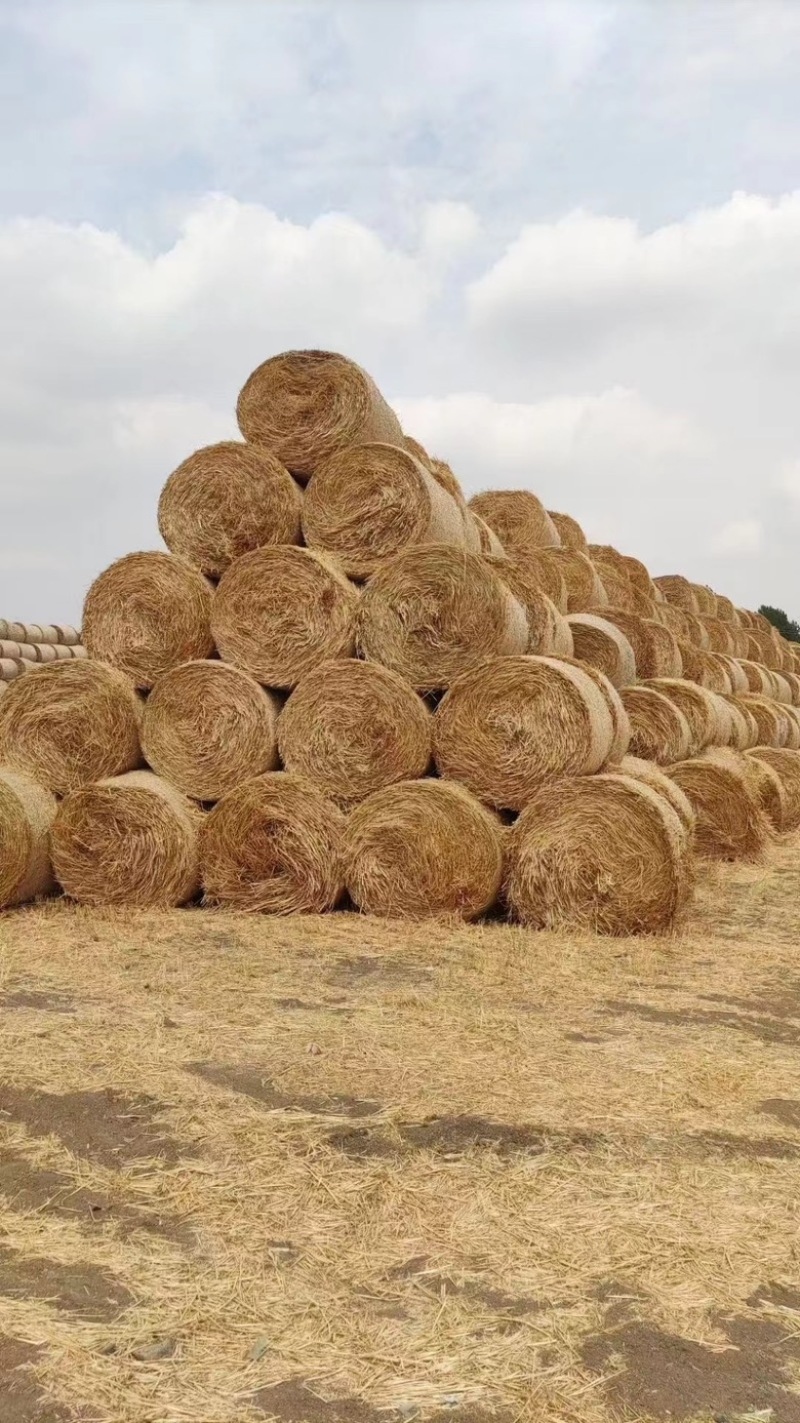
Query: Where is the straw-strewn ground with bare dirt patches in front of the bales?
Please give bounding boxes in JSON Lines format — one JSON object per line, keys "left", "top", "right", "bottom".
{"left": 0, "top": 844, "right": 800, "bottom": 1423}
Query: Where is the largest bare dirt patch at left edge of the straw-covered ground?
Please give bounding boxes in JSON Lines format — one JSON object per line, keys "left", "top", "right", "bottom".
{"left": 0, "top": 1083, "right": 191, "bottom": 1170}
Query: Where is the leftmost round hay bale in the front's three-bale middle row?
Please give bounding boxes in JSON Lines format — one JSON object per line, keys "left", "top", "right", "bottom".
{"left": 84, "top": 554, "right": 214, "bottom": 689}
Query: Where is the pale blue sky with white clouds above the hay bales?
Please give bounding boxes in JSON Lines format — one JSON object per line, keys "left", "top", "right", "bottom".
{"left": 0, "top": 0, "right": 800, "bottom": 622}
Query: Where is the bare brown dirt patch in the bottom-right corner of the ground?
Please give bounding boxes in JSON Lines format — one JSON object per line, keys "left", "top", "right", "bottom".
{"left": 582, "top": 1316, "right": 800, "bottom": 1423}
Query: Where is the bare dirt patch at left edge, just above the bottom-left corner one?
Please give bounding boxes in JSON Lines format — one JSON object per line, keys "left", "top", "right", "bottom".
{"left": 0, "top": 1245, "right": 134, "bottom": 1322}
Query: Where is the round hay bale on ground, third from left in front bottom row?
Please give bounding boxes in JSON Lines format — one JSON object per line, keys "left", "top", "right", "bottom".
{"left": 201, "top": 771, "right": 346, "bottom": 915}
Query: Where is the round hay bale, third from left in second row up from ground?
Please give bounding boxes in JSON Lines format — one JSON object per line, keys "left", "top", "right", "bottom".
{"left": 278, "top": 657, "right": 433, "bottom": 810}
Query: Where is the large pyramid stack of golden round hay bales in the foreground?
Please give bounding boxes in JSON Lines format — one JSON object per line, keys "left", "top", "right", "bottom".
{"left": 0, "top": 351, "right": 800, "bottom": 933}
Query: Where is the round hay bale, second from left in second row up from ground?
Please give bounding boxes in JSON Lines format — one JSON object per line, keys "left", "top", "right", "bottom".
{"left": 142, "top": 662, "right": 279, "bottom": 801}
